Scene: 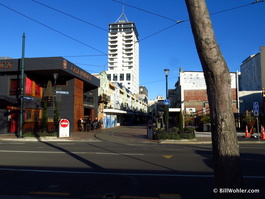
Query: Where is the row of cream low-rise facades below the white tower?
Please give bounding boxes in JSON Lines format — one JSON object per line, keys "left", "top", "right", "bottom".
{"left": 96, "top": 71, "right": 148, "bottom": 128}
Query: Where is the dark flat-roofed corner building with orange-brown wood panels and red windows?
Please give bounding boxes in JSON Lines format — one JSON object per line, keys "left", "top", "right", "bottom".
{"left": 0, "top": 57, "right": 100, "bottom": 133}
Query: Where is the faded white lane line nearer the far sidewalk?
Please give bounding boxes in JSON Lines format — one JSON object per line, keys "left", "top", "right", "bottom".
{"left": 0, "top": 150, "right": 144, "bottom": 156}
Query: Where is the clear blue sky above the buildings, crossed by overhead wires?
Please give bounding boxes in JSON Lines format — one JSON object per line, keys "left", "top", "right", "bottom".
{"left": 0, "top": 0, "right": 265, "bottom": 99}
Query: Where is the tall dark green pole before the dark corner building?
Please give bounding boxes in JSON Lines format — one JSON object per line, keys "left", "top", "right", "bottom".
{"left": 18, "top": 33, "right": 26, "bottom": 138}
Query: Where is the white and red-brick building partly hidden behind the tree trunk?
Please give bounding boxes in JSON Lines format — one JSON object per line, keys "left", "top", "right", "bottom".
{"left": 173, "top": 70, "right": 239, "bottom": 126}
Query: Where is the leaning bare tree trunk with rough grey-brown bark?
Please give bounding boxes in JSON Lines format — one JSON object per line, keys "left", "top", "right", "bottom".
{"left": 186, "top": 0, "right": 243, "bottom": 198}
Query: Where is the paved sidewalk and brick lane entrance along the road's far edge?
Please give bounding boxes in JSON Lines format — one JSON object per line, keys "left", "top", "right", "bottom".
{"left": 0, "top": 126, "right": 265, "bottom": 144}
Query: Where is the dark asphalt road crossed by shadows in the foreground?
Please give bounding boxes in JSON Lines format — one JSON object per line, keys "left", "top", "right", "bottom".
{"left": 0, "top": 141, "right": 265, "bottom": 199}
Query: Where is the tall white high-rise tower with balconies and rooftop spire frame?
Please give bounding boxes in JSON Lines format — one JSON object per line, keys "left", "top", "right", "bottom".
{"left": 107, "top": 13, "right": 139, "bottom": 94}
